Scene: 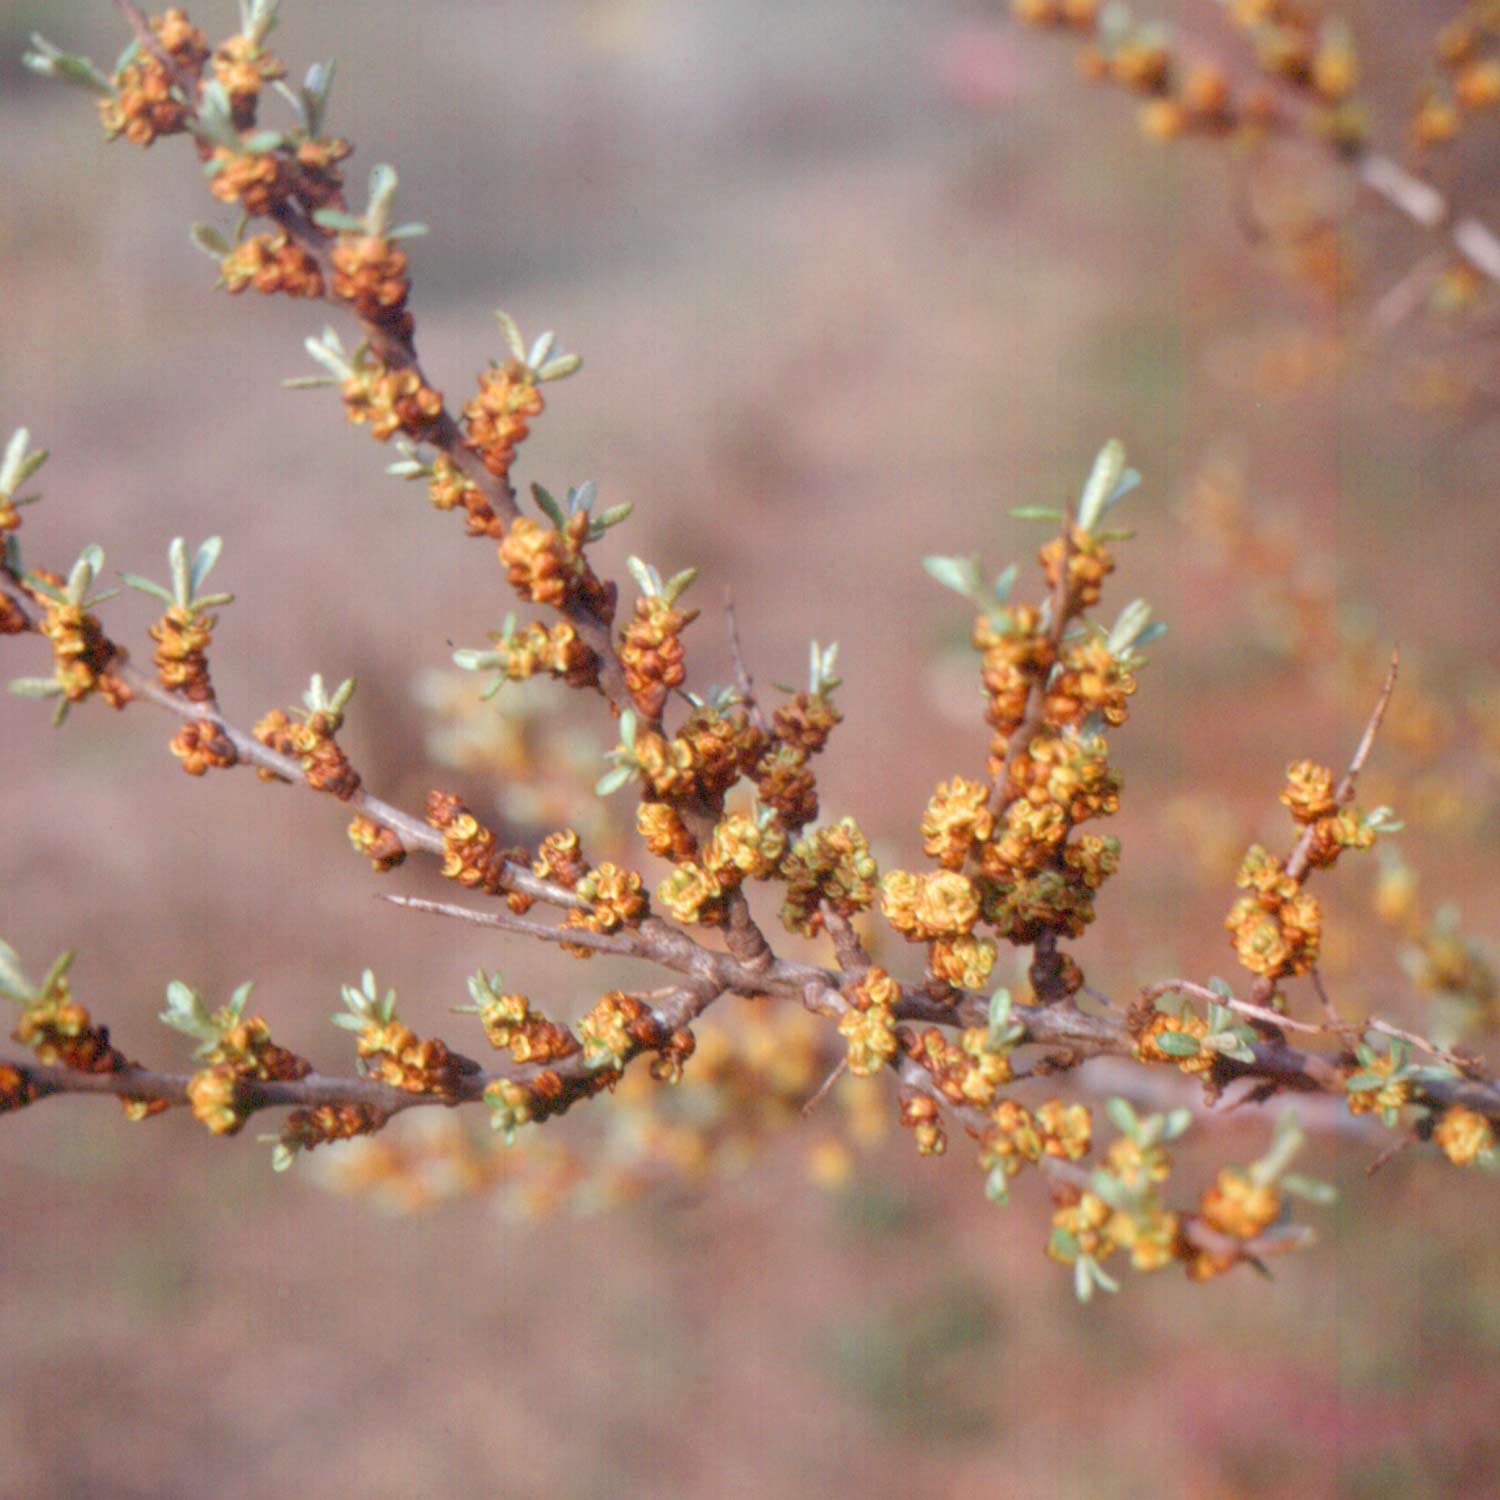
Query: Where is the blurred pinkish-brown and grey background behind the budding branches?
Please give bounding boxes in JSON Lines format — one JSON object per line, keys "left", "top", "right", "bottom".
{"left": 0, "top": 0, "right": 1500, "bottom": 1500}
